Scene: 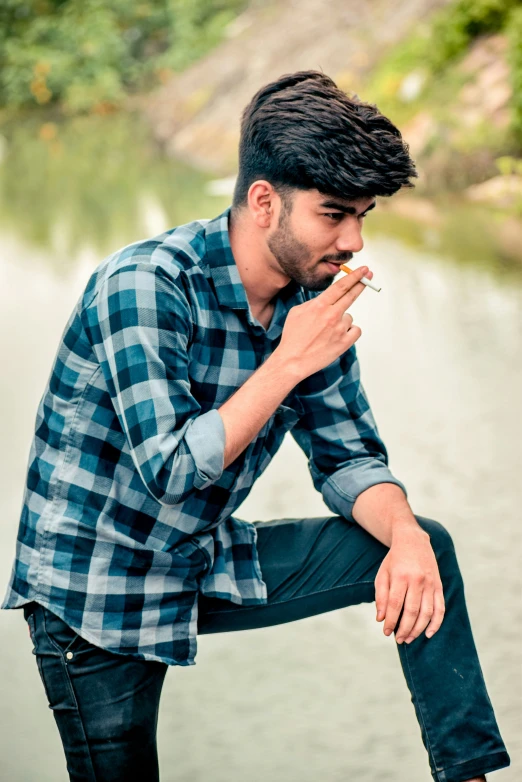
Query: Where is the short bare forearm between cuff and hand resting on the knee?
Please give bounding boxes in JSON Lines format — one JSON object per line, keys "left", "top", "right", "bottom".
{"left": 352, "top": 483, "right": 426, "bottom": 547}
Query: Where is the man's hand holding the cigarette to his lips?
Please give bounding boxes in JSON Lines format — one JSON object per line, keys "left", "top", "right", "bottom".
{"left": 276, "top": 266, "right": 373, "bottom": 379}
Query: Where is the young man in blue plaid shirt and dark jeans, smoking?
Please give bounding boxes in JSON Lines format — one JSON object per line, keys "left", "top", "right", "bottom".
{"left": 3, "top": 71, "right": 510, "bottom": 782}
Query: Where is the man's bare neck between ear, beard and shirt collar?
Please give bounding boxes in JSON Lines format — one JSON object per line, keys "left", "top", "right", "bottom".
{"left": 229, "top": 208, "right": 290, "bottom": 310}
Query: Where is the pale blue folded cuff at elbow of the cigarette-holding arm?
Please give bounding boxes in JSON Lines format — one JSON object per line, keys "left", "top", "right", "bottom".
{"left": 185, "top": 410, "right": 225, "bottom": 489}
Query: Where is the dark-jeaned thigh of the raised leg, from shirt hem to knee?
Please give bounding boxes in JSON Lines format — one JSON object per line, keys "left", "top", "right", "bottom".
{"left": 198, "top": 516, "right": 389, "bottom": 633}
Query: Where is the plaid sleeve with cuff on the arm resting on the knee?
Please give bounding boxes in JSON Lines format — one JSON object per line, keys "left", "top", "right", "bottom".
{"left": 292, "top": 346, "right": 407, "bottom": 518}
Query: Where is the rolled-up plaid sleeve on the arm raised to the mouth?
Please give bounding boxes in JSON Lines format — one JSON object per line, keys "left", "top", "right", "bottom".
{"left": 83, "top": 262, "right": 225, "bottom": 505}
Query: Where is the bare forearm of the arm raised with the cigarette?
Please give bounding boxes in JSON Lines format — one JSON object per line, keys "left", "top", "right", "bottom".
{"left": 218, "top": 349, "right": 301, "bottom": 468}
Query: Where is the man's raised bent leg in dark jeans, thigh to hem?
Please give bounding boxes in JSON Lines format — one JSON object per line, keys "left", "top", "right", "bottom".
{"left": 198, "top": 516, "right": 510, "bottom": 782}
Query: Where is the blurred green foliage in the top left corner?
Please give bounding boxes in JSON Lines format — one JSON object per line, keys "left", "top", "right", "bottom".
{"left": 0, "top": 0, "right": 246, "bottom": 114}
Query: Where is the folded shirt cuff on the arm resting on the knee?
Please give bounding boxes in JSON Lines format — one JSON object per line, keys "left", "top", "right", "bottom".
{"left": 322, "top": 458, "right": 408, "bottom": 518}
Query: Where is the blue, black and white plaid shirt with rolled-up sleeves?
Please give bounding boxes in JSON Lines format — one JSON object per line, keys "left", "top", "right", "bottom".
{"left": 1, "top": 208, "right": 405, "bottom": 665}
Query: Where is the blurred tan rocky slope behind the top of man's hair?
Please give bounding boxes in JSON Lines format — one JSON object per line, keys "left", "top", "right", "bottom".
{"left": 144, "top": 0, "right": 448, "bottom": 175}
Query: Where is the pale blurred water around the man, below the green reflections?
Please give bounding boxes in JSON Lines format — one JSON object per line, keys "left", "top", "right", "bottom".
{"left": 0, "top": 118, "right": 522, "bottom": 782}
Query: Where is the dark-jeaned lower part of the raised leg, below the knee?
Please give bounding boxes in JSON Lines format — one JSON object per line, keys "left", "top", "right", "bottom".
{"left": 397, "top": 517, "right": 510, "bottom": 782}
